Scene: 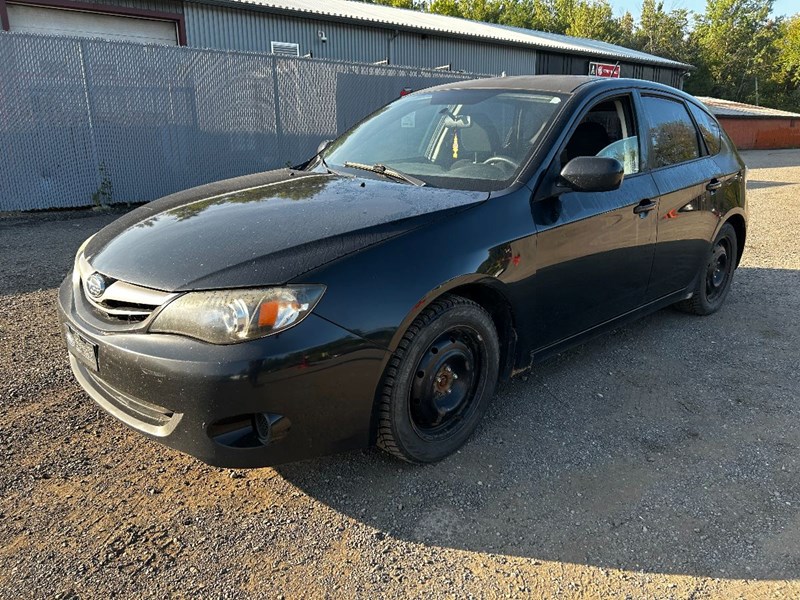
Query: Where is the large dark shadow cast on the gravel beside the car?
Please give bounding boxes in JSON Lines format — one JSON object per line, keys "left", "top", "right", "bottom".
{"left": 277, "top": 268, "right": 800, "bottom": 579}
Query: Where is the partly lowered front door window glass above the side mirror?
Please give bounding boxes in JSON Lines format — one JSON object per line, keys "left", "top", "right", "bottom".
{"left": 561, "top": 96, "right": 640, "bottom": 175}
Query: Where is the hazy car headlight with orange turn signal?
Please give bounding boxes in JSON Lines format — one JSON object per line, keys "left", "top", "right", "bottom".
{"left": 150, "top": 285, "right": 325, "bottom": 344}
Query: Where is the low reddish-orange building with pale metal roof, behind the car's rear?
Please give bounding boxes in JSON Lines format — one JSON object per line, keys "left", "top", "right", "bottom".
{"left": 698, "top": 97, "right": 800, "bottom": 150}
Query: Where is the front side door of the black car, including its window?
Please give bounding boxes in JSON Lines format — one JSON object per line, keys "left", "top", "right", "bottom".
{"left": 533, "top": 93, "right": 658, "bottom": 348}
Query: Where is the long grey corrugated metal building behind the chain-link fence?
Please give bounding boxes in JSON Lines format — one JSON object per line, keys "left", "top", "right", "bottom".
{"left": 0, "top": 0, "right": 691, "bottom": 87}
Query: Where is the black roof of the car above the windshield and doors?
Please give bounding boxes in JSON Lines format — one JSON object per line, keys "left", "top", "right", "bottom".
{"left": 428, "top": 75, "right": 697, "bottom": 102}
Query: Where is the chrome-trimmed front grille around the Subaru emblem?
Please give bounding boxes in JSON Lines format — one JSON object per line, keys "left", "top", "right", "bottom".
{"left": 75, "top": 256, "right": 175, "bottom": 325}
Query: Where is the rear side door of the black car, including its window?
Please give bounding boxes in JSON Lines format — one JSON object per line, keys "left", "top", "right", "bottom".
{"left": 641, "top": 93, "right": 720, "bottom": 301}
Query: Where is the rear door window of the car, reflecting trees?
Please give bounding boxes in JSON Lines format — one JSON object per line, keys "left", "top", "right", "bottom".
{"left": 642, "top": 96, "right": 700, "bottom": 169}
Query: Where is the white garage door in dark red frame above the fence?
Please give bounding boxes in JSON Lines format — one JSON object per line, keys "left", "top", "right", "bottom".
{"left": 8, "top": 4, "right": 178, "bottom": 46}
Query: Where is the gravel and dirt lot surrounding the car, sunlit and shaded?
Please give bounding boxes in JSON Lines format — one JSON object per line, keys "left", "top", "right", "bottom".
{"left": 0, "top": 151, "right": 800, "bottom": 599}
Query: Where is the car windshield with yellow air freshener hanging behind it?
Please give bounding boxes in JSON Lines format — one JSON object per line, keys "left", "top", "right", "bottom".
{"left": 323, "top": 89, "right": 564, "bottom": 191}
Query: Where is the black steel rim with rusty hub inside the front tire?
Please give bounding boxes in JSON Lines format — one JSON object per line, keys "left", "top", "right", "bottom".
{"left": 409, "top": 328, "right": 481, "bottom": 436}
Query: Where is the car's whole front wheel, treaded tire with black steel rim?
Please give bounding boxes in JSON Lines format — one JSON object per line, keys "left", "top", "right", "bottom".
{"left": 377, "top": 295, "right": 500, "bottom": 463}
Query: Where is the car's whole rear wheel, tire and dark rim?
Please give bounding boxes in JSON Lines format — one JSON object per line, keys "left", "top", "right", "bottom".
{"left": 675, "top": 223, "right": 738, "bottom": 315}
